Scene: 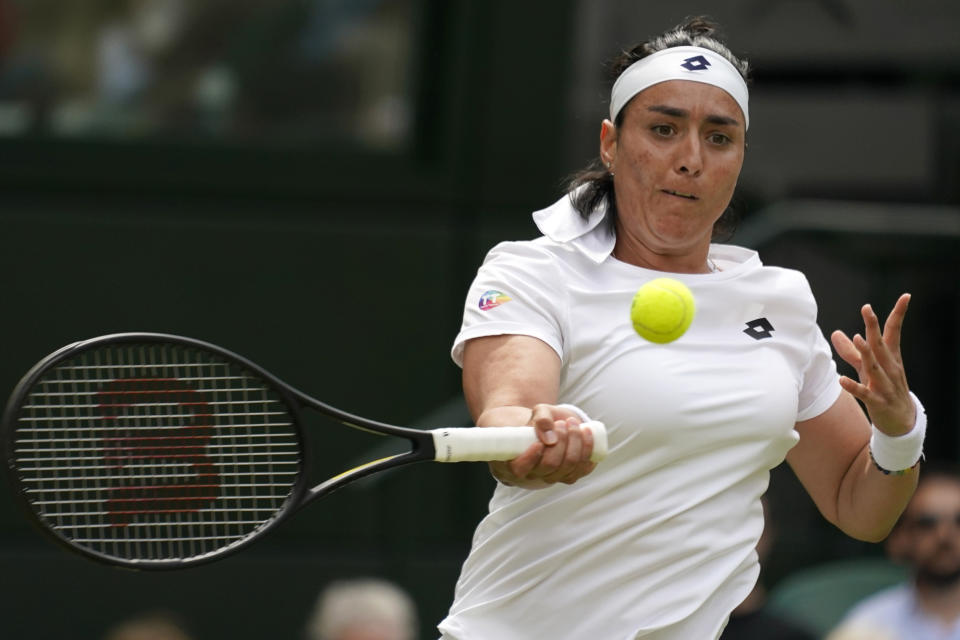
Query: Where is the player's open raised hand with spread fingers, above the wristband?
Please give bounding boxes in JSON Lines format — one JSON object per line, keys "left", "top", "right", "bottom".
{"left": 830, "top": 293, "right": 917, "bottom": 436}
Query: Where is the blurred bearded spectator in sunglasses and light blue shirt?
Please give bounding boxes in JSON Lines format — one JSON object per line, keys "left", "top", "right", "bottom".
{"left": 829, "top": 468, "right": 960, "bottom": 640}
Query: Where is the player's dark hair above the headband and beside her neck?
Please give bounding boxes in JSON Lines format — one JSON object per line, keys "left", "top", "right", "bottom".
{"left": 567, "top": 16, "right": 750, "bottom": 240}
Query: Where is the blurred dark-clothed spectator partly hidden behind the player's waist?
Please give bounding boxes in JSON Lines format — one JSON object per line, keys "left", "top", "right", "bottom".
{"left": 720, "top": 497, "right": 816, "bottom": 640}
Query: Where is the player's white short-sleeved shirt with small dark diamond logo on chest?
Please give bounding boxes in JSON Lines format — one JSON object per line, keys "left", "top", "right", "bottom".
{"left": 439, "top": 198, "right": 840, "bottom": 640}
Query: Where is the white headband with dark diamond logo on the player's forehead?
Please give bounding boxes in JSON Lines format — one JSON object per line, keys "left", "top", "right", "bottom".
{"left": 610, "top": 47, "right": 750, "bottom": 129}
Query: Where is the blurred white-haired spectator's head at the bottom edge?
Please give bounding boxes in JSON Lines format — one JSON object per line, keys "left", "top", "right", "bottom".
{"left": 307, "top": 578, "right": 418, "bottom": 640}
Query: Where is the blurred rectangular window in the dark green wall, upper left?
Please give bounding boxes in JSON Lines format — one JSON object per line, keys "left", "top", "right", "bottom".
{"left": 0, "top": 0, "right": 415, "bottom": 142}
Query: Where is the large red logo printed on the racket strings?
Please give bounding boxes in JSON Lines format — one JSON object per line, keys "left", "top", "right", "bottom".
{"left": 97, "top": 378, "right": 221, "bottom": 527}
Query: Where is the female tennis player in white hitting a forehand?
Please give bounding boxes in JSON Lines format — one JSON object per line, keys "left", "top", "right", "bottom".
{"left": 439, "top": 18, "right": 925, "bottom": 640}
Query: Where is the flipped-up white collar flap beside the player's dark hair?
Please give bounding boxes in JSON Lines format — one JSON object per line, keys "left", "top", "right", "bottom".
{"left": 533, "top": 191, "right": 616, "bottom": 264}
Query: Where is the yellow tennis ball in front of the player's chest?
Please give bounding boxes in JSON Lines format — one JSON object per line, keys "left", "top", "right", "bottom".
{"left": 630, "top": 278, "right": 696, "bottom": 344}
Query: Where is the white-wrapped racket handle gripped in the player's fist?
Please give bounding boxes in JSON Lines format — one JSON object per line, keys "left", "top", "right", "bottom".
{"left": 430, "top": 420, "right": 607, "bottom": 462}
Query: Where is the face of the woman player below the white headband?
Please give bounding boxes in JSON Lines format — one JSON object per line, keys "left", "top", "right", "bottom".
{"left": 600, "top": 80, "right": 746, "bottom": 255}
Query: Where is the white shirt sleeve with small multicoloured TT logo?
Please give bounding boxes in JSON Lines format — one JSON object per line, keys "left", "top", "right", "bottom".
{"left": 451, "top": 241, "right": 564, "bottom": 366}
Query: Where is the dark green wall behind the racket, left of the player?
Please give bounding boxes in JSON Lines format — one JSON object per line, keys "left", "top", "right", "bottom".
{"left": 0, "top": 0, "right": 572, "bottom": 640}
